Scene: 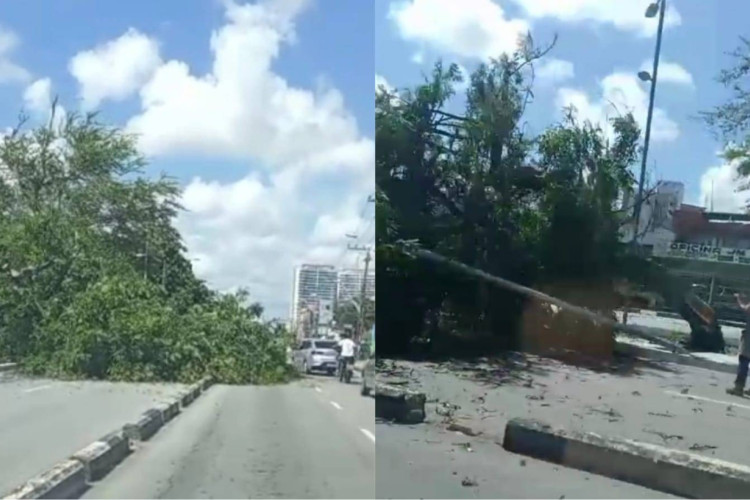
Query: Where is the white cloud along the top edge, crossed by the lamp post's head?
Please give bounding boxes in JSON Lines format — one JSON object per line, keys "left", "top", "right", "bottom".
{"left": 513, "top": 0, "right": 682, "bottom": 36}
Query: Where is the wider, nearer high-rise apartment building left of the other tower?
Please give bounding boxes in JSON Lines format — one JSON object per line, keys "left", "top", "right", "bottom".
{"left": 291, "top": 264, "right": 337, "bottom": 337}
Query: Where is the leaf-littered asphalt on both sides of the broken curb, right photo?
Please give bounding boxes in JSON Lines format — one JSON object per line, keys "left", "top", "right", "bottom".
{"left": 377, "top": 356, "right": 750, "bottom": 498}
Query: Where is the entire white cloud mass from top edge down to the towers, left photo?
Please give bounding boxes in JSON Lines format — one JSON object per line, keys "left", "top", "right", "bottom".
{"left": 83, "top": 0, "right": 375, "bottom": 316}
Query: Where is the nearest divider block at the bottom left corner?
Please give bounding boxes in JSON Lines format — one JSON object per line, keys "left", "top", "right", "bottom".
{"left": 3, "top": 459, "right": 87, "bottom": 499}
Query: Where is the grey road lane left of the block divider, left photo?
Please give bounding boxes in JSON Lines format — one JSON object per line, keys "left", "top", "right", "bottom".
{"left": 0, "top": 373, "right": 187, "bottom": 496}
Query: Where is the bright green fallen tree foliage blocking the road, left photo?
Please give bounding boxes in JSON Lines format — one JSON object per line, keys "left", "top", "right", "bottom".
{"left": 0, "top": 111, "right": 290, "bottom": 383}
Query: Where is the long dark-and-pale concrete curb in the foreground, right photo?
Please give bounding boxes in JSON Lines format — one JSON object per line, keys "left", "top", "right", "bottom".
{"left": 503, "top": 419, "right": 750, "bottom": 498}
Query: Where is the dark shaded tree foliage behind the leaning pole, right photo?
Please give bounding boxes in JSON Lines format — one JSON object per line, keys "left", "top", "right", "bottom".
{"left": 376, "top": 39, "right": 640, "bottom": 355}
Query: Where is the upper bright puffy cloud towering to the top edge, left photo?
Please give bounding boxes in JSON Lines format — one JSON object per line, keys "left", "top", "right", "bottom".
{"left": 127, "top": 0, "right": 368, "bottom": 172}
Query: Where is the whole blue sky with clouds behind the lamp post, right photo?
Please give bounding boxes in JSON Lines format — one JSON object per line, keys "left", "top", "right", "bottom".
{"left": 375, "top": 0, "right": 750, "bottom": 210}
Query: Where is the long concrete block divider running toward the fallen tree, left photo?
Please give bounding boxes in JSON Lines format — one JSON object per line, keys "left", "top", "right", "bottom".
{"left": 0, "top": 378, "right": 213, "bottom": 500}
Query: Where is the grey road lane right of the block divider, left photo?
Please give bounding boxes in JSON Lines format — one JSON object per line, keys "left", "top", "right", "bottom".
{"left": 84, "top": 377, "right": 375, "bottom": 498}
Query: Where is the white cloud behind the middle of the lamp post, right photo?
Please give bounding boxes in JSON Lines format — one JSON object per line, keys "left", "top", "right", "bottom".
{"left": 556, "top": 72, "right": 680, "bottom": 142}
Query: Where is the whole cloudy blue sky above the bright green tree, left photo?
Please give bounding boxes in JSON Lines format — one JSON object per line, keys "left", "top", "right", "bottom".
{"left": 0, "top": 0, "right": 374, "bottom": 317}
